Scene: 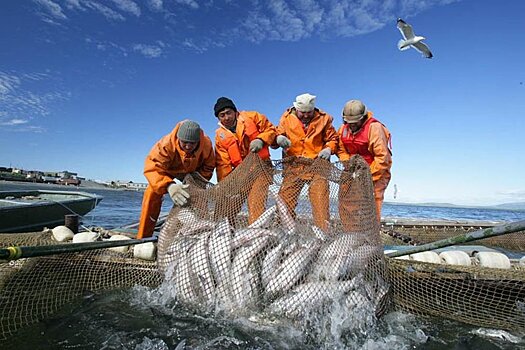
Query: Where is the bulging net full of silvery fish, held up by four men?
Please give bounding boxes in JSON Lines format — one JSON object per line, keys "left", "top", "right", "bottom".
{"left": 158, "top": 156, "right": 389, "bottom": 330}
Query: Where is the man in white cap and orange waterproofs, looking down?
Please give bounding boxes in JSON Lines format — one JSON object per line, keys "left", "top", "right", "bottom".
{"left": 276, "top": 93, "right": 337, "bottom": 230}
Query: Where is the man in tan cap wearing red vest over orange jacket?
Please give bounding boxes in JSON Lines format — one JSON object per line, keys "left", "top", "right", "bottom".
{"left": 337, "top": 100, "right": 392, "bottom": 222}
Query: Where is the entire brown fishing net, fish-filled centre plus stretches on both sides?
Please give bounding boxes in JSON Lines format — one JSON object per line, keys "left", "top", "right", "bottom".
{"left": 0, "top": 156, "right": 525, "bottom": 339}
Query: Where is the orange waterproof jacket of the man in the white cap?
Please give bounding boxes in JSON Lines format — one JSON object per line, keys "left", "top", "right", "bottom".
{"left": 277, "top": 107, "right": 338, "bottom": 159}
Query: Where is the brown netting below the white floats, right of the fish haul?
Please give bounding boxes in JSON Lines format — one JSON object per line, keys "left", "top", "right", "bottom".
{"left": 388, "top": 258, "right": 525, "bottom": 334}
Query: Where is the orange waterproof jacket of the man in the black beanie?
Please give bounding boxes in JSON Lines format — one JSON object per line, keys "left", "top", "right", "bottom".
{"left": 215, "top": 111, "right": 276, "bottom": 181}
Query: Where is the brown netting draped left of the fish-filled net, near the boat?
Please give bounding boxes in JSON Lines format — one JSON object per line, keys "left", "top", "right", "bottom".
{"left": 0, "top": 230, "right": 162, "bottom": 340}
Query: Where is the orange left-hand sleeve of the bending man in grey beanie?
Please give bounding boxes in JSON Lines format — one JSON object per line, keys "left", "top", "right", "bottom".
{"left": 144, "top": 125, "right": 179, "bottom": 195}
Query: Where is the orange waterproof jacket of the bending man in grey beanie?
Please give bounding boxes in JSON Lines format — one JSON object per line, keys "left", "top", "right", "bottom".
{"left": 144, "top": 122, "right": 215, "bottom": 195}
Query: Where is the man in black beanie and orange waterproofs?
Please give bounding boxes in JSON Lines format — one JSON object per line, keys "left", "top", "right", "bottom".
{"left": 213, "top": 97, "right": 276, "bottom": 223}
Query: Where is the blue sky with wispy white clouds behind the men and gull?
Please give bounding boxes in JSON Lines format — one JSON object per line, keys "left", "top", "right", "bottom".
{"left": 0, "top": 0, "right": 525, "bottom": 204}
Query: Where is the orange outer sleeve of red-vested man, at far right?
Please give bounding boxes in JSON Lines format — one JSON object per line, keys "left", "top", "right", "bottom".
{"left": 368, "top": 123, "right": 392, "bottom": 182}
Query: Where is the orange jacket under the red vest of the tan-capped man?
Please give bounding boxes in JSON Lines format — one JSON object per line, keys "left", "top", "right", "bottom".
{"left": 337, "top": 112, "right": 392, "bottom": 182}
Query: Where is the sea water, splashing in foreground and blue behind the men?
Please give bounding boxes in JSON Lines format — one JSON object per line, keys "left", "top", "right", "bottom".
{"left": 0, "top": 182, "right": 525, "bottom": 350}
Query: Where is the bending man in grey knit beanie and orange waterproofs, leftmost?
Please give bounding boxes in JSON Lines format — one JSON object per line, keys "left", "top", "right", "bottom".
{"left": 137, "top": 120, "right": 215, "bottom": 239}
